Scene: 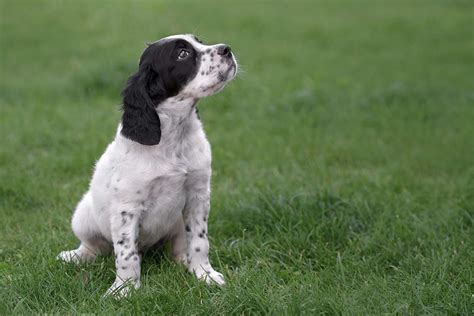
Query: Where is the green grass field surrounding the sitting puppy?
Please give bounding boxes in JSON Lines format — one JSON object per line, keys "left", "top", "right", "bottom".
{"left": 0, "top": 0, "right": 474, "bottom": 315}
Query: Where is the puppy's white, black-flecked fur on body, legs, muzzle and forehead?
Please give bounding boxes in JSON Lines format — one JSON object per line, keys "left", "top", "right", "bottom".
{"left": 58, "top": 35, "right": 237, "bottom": 296}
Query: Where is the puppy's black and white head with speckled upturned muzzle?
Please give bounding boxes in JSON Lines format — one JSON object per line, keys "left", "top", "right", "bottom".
{"left": 121, "top": 35, "right": 238, "bottom": 145}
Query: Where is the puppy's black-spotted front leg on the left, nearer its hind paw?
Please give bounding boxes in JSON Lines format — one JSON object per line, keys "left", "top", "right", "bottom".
{"left": 105, "top": 207, "right": 141, "bottom": 297}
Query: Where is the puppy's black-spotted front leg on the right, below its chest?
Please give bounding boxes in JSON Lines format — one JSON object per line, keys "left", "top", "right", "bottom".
{"left": 183, "top": 171, "right": 225, "bottom": 285}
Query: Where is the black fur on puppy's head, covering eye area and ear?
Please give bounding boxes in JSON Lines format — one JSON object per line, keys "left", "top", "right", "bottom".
{"left": 121, "top": 39, "right": 200, "bottom": 145}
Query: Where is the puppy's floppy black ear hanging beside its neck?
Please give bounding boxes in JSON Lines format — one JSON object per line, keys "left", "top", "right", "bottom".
{"left": 121, "top": 69, "right": 161, "bottom": 145}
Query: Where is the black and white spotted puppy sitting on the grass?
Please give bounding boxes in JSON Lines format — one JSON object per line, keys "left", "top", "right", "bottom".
{"left": 58, "top": 35, "right": 238, "bottom": 296}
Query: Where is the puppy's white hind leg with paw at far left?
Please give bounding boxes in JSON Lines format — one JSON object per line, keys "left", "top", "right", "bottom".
{"left": 57, "top": 192, "right": 111, "bottom": 263}
